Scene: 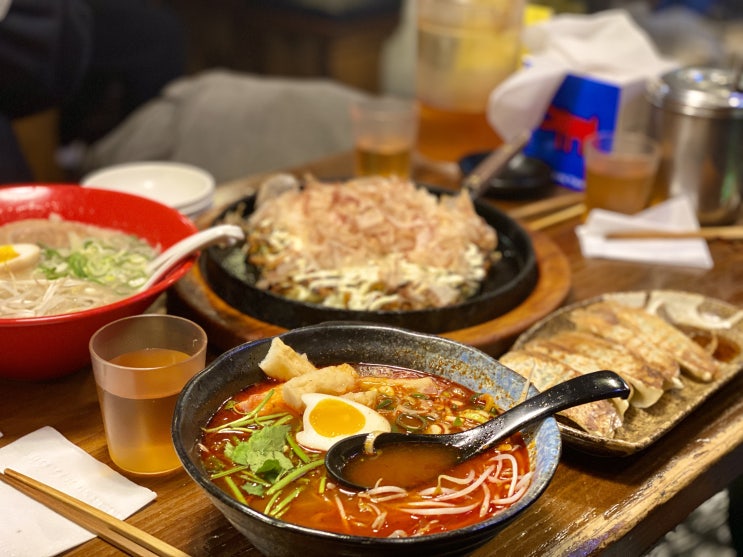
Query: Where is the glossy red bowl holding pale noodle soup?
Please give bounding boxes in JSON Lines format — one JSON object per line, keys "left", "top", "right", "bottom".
{"left": 0, "top": 185, "right": 197, "bottom": 381}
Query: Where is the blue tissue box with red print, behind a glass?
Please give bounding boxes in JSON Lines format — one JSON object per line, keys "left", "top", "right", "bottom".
{"left": 524, "top": 74, "right": 647, "bottom": 190}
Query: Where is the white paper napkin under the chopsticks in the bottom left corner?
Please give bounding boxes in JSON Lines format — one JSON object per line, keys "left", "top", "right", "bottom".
{"left": 0, "top": 427, "right": 156, "bottom": 557}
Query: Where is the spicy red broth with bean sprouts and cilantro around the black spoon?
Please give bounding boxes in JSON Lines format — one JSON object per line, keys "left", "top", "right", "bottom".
{"left": 200, "top": 364, "right": 531, "bottom": 537}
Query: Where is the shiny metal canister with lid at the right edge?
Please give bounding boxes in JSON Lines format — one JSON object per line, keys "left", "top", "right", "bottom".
{"left": 647, "top": 67, "right": 743, "bottom": 225}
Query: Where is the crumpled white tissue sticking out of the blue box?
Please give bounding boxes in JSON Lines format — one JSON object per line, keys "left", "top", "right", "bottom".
{"left": 488, "top": 9, "right": 676, "bottom": 140}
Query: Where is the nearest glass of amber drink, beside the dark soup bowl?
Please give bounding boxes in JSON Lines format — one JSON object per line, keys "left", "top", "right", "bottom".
{"left": 89, "top": 313, "right": 207, "bottom": 474}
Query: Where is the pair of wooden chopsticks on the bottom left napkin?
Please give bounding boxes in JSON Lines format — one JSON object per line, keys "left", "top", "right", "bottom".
{"left": 0, "top": 468, "right": 189, "bottom": 557}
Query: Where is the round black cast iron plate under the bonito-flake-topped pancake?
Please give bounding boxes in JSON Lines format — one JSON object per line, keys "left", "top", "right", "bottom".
{"left": 199, "top": 186, "right": 539, "bottom": 333}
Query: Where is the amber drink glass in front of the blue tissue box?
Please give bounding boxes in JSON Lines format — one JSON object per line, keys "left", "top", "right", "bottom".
{"left": 583, "top": 131, "right": 660, "bottom": 214}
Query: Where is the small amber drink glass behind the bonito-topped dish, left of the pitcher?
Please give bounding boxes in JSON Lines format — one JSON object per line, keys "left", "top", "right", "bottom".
{"left": 350, "top": 97, "right": 418, "bottom": 178}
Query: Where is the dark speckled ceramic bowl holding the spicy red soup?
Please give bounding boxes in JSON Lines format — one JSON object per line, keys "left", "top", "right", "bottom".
{"left": 173, "top": 323, "right": 561, "bottom": 557}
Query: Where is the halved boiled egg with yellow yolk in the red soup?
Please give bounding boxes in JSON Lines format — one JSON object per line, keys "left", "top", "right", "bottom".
{"left": 297, "top": 393, "right": 391, "bottom": 451}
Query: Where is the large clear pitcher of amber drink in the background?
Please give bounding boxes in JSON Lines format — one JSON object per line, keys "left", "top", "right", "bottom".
{"left": 416, "top": 0, "right": 525, "bottom": 162}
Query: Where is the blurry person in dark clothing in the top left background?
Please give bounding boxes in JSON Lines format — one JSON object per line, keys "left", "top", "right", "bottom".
{"left": 0, "top": 0, "right": 186, "bottom": 184}
